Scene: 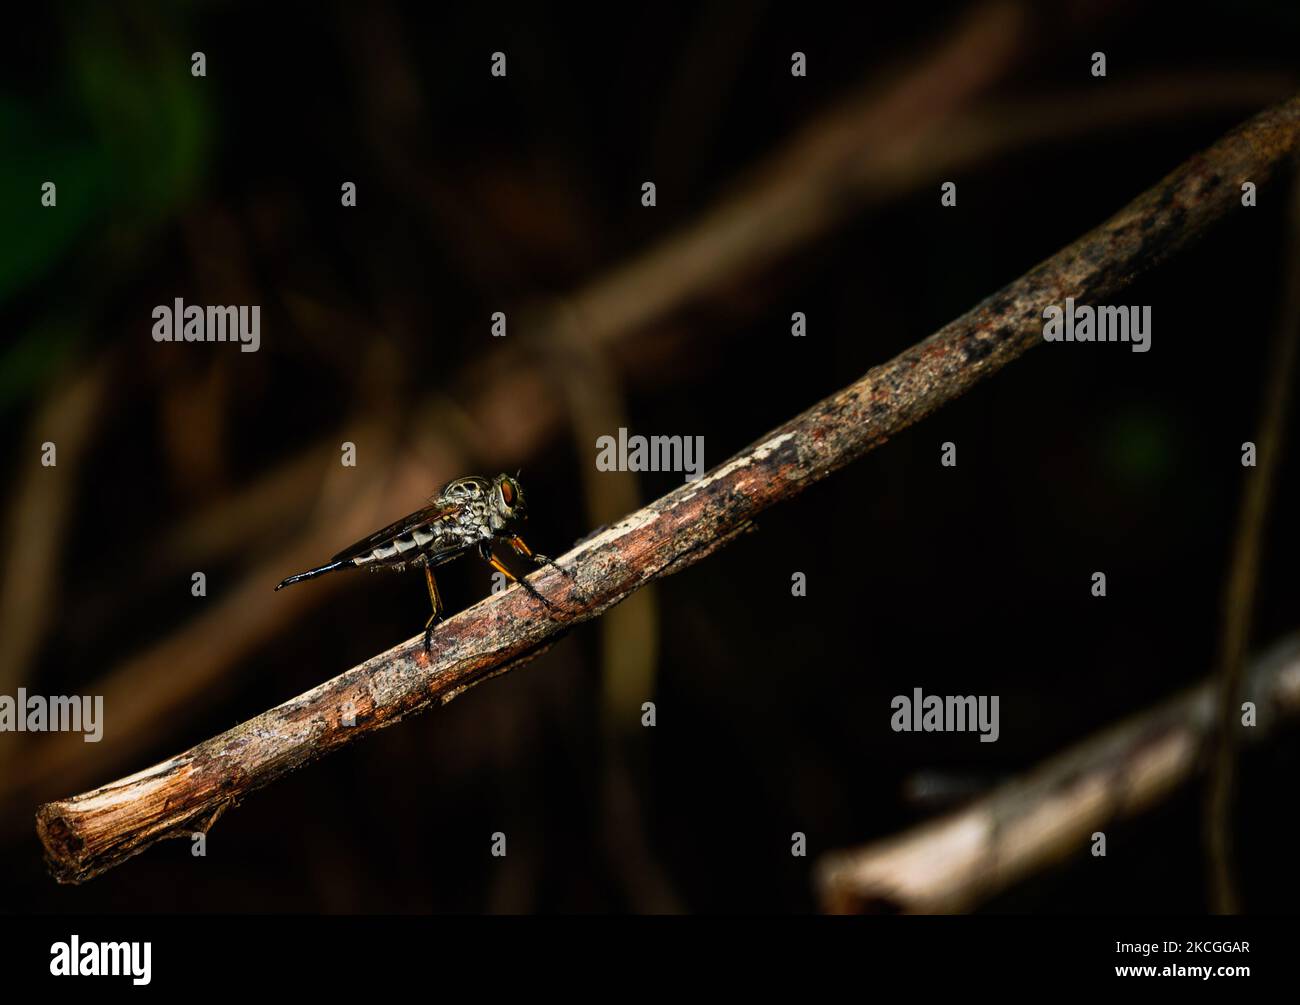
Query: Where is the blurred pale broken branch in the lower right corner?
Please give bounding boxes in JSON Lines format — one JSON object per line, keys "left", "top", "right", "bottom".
{"left": 816, "top": 636, "right": 1300, "bottom": 914}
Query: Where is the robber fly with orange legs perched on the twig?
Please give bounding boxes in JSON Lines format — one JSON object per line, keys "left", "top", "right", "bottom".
{"left": 276, "top": 475, "right": 573, "bottom": 653}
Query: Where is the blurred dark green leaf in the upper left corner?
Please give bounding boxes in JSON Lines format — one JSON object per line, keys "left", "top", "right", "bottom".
{"left": 0, "top": 5, "right": 213, "bottom": 410}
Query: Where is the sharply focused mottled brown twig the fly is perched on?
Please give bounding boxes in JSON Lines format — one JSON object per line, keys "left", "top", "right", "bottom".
{"left": 36, "top": 92, "right": 1300, "bottom": 883}
